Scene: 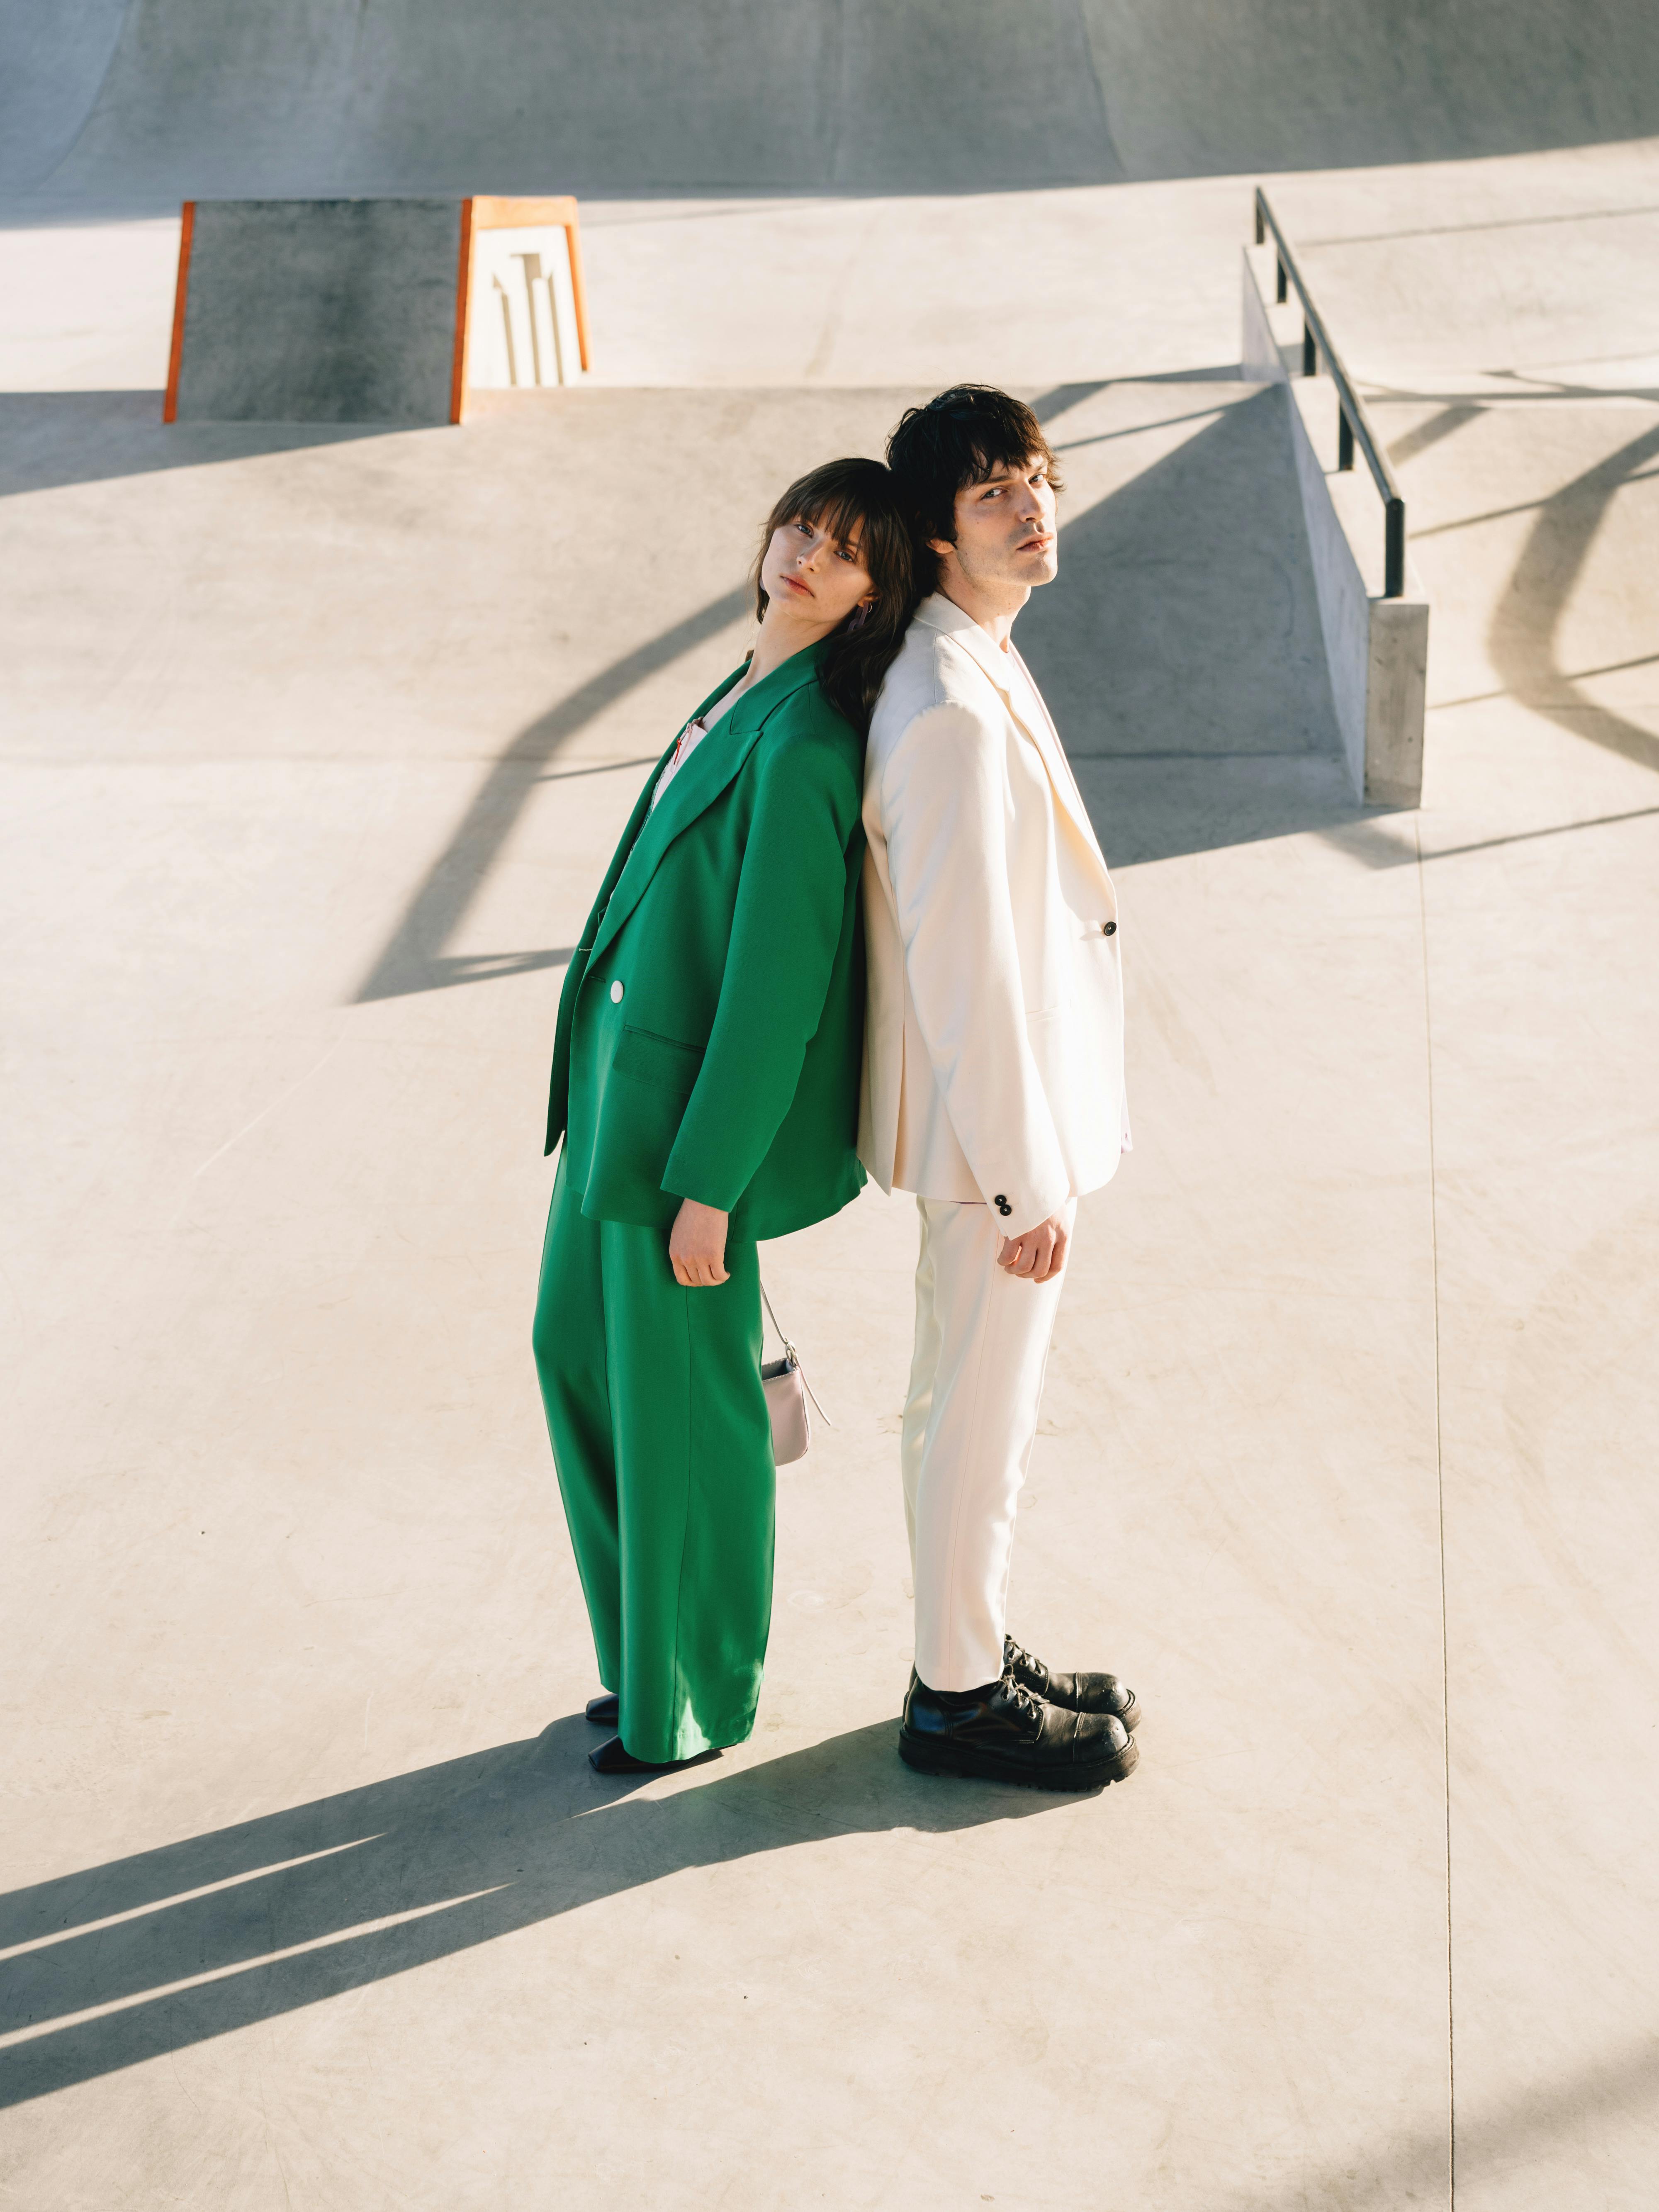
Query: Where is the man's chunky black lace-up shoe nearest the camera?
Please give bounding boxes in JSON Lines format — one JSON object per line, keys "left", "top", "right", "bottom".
{"left": 898, "top": 1672, "right": 1139, "bottom": 1789}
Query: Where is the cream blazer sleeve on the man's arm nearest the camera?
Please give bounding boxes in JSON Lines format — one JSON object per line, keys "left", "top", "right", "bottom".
{"left": 881, "top": 703, "right": 1070, "bottom": 1236}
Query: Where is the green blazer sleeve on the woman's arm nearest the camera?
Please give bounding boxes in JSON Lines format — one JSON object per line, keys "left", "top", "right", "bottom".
{"left": 662, "top": 710, "right": 861, "bottom": 1212}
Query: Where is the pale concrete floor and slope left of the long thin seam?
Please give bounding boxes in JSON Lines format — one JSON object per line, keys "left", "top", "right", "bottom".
{"left": 5, "top": 383, "right": 1447, "bottom": 2205}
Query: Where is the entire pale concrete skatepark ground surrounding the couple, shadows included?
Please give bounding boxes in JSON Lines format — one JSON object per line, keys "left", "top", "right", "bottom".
{"left": 0, "top": 52, "right": 1659, "bottom": 2212}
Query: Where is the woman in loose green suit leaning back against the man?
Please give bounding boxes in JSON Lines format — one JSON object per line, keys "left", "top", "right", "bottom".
{"left": 535, "top": 460, "right": 914, "bottom": 1774}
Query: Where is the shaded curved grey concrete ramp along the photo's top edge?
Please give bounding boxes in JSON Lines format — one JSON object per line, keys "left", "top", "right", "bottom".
{"left": 19, "top": 0, "right": 1659, "bottom": 204}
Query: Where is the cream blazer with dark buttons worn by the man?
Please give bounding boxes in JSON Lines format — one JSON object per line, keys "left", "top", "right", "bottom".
{"left": 858, "top": 593, "right": 1130, "bottom": 1236}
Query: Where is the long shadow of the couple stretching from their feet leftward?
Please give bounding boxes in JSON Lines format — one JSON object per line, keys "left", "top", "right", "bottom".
{"left": 0, "top": 1716, "right": 1055, "bottom": 2106}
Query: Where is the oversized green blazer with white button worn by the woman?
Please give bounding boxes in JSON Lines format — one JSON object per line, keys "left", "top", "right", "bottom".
{"left": 546, "top": 646, "right": 865, "bottom": 1236}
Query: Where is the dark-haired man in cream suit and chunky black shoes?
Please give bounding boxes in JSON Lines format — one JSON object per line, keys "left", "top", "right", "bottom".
{"left": 858, "top": 385, "right": 1139, "bottom": 1789}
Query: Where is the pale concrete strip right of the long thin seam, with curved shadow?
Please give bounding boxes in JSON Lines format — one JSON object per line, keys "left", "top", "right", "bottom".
{"left": 1380, "top": 392, "right": 1659, "bottom": 2212}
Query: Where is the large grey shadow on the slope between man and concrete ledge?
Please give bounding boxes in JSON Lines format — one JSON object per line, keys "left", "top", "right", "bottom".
{"left": 1020, "top": 385, "right": 1376, "bottom": 865}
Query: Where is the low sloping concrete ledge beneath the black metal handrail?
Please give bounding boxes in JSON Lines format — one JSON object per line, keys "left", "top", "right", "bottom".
{"left": 1241, "top": 246, "right": 1429, "bottom": 808}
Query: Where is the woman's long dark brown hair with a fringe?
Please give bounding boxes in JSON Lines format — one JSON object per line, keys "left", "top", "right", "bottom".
{"left": 754, "top": 460, "right": 918, "bottom": 737}
